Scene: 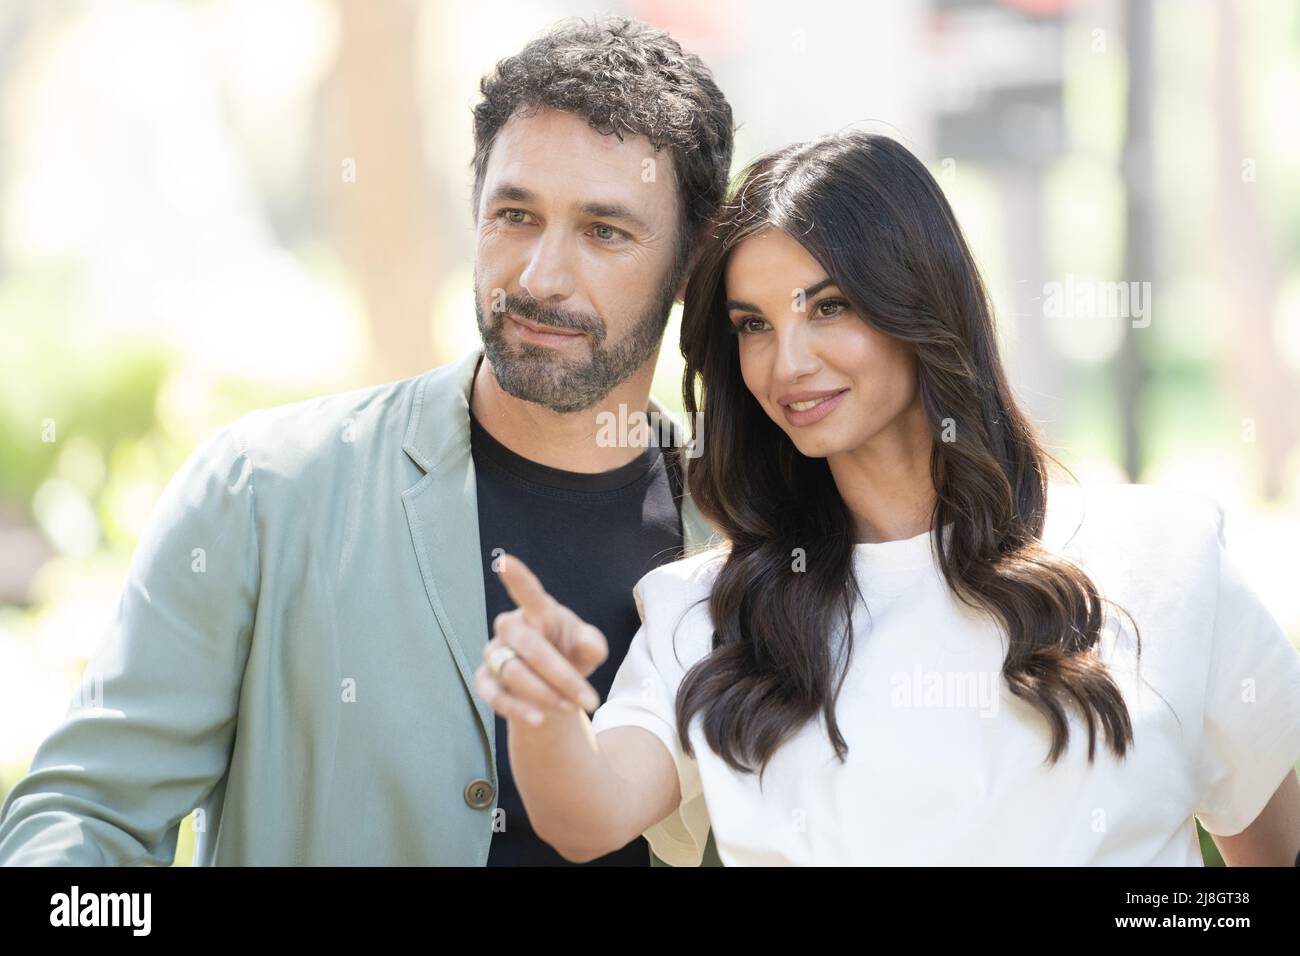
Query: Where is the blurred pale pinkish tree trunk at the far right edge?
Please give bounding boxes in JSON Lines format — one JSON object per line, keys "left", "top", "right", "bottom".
{"left": 1214, "top": 0, "right": 1300, "bottom": 501}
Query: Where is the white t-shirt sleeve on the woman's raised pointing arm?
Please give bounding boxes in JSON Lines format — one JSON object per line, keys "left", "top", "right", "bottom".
{"left": 592, "top": 570, "right": 711, "bottom": 866}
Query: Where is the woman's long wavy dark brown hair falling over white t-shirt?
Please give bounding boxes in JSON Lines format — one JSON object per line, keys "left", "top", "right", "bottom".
{"left": 676, "top": 131, "right": 1140, "bottom": 779}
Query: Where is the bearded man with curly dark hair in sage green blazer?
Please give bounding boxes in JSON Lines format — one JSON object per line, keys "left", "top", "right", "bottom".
{"left": 0, "top": 20, "right": 733, "bottom": 865}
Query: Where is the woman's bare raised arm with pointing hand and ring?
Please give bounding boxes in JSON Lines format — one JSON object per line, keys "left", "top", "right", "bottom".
{"left": 475, "top": 555, "right": 681, "bottom": 862}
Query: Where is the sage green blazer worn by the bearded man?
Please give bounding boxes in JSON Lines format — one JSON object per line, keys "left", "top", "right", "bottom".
{"left": 0, "top": 349, "right": 720, "bottom": 866}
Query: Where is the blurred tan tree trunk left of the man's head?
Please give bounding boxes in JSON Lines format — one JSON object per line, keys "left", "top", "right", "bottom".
{"left": 320, "top": 0, "right": 446, "bottom": 382}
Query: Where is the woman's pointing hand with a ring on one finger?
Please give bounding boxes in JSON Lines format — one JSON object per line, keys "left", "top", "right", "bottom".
{"left": 475, "top": 554, "right": 610, "bottom": 726}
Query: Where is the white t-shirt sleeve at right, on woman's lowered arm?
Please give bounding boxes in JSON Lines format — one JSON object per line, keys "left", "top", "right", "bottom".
{"left": 1195, "top": 514, "right": 1300, "bottom": 836}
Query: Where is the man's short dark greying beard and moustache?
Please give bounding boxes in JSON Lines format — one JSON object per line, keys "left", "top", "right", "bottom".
{"left": 475, "top": 265, "right": 681, "bottom": 414}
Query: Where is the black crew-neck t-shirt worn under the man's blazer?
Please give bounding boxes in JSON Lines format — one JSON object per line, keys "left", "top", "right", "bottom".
{"left": 469, "top": 400, "right": 683, "bottom": 866}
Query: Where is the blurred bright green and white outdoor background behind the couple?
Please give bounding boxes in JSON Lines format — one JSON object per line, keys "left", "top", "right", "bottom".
{"left": 0, "top": 0, "right": 1300, "bottom": 865}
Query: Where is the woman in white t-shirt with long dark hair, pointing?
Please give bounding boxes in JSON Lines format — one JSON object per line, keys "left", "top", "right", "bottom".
{"left": 478, "top": 133, "right": 1300, "bottom": 865}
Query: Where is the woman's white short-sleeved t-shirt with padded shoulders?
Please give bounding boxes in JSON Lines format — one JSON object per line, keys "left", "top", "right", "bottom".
{"left": 592, "top": 485, "right": 1300, "bottom": 866}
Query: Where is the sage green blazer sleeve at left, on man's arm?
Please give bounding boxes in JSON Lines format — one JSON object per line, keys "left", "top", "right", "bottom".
{"left": 0, "top": 423, "right": 260, "bottom": 866}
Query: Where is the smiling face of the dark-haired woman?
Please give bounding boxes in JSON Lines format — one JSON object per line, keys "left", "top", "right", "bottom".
{"left": 725, "top": 229, "right": 924, "bottom": 458}
